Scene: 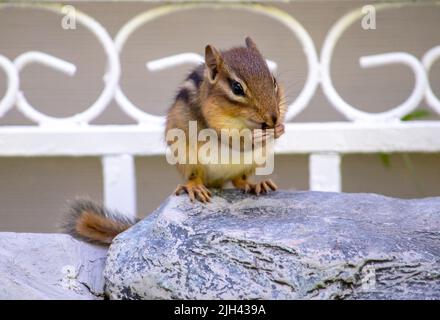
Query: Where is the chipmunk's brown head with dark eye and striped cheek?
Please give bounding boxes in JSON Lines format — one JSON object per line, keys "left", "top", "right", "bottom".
{"left": 202, "top": 37, "right": 283, "bottom": 129}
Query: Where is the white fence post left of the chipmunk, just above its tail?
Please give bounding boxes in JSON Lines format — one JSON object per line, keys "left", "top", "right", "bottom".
{"left": 102, "top": 154, "right": 136, "bottom": 217}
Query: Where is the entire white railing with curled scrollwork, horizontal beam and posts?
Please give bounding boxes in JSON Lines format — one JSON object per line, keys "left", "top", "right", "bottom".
{"left": 0, "top": 2, "right": 440, "bottom": 215}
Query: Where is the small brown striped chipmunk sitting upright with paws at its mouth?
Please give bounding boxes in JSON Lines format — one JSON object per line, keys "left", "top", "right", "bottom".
{"left": 63, "top": 37, "right": 286, "bottom": 244}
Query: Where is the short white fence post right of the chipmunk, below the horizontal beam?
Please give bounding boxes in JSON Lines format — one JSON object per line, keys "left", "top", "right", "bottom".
{"left": 309, "top": 153, "right": 341, "bottom": 192}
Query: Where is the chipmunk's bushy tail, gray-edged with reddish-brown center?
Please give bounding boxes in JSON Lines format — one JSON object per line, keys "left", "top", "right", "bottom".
{"left": 62, "top": 200, "right": 137, "bottom": 245}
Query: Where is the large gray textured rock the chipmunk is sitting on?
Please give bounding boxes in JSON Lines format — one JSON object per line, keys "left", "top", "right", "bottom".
{"left": 104, "top": 190, "right": 440, "bottom": 299}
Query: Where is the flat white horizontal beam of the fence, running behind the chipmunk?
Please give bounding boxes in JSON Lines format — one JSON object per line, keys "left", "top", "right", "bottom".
{"left": 0, "top": 121, "right": 440, "bottom": 157}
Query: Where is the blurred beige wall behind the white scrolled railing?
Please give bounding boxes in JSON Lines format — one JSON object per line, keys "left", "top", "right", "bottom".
{"left": 0, "top": 1, "right": 440, "bottom": 232}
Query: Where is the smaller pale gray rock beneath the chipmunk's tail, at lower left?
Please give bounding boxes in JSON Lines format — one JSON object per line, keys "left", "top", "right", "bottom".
{"left": 0, "top": 232, "right": 107, "bottom": 299}
